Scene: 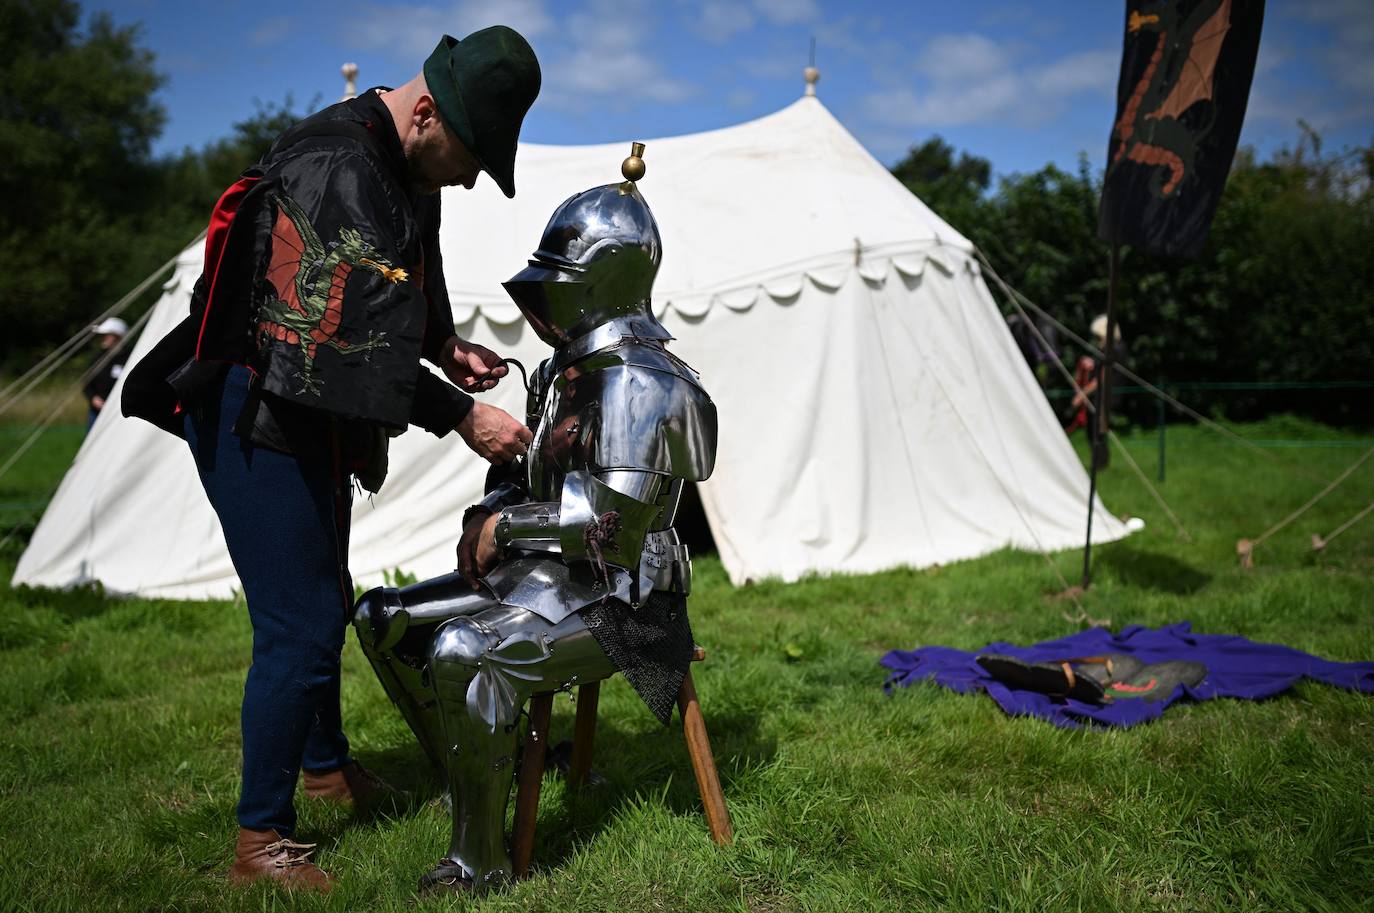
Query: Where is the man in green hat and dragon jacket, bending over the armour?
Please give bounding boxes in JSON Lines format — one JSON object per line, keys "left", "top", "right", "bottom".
{"left": 125, "top": 26, "right": 540, "bottom": 890}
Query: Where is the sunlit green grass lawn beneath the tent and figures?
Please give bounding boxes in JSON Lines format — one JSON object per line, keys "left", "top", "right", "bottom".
{"left": 0, "top": 419, "right": 1374, "bottom": 913}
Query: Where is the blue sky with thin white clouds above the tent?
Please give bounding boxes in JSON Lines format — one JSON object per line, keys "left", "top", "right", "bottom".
{"left": 87, "top": 0, "right": 1374, "bottom": 173}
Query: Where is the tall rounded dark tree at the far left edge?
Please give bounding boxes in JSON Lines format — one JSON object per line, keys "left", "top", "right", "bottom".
{"left": 0, "top": 0, "right": 164, "bottom": 358}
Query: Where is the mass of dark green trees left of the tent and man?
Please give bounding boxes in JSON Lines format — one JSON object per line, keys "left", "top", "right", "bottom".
{"left": 0, "top": 0, "right": 311, "bottom": 363}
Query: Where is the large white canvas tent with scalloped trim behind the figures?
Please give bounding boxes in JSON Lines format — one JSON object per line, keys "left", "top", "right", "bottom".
{"left": 15, "top": 98, "right": 1125, "bottom": 598}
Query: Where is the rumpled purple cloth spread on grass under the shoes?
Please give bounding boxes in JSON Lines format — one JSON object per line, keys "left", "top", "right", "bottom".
{"left": 878, "top": 622, "right": 1374, "bottom": 726}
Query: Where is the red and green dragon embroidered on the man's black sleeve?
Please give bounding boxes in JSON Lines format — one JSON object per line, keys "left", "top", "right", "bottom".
{"left": 257, "top": 194, "right": 408, "bottom": 395}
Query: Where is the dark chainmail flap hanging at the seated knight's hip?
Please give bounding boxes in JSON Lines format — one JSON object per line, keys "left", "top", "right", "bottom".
{"left": 581, "top": 593, "right": 694, "bottom": 726}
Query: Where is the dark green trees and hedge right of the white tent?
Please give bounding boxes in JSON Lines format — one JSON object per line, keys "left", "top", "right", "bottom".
{"left": 893, "top": 125, "right": 1374, "bottom": 424}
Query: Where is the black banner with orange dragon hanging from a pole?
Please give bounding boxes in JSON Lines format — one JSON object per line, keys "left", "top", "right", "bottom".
{"left": 1098, "top": 0, "right": 1264, "bottom": 257}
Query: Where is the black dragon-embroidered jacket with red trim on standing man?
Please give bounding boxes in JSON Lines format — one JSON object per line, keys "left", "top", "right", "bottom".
{"left": 124, "top": 89, "right": 471, "bottom": 452}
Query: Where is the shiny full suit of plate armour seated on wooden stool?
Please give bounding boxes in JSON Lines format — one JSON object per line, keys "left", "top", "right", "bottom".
{"left": 354, "top": 147, "right": 716, "bottom": 888}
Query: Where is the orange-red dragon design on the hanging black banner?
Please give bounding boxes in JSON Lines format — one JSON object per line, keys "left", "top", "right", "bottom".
{"left": 1109, "top": 0, "right": 1231, "bottom": 198}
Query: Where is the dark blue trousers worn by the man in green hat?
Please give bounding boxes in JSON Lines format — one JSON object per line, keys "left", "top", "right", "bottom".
{"left": 185, "top": 367, "right": 353, "bottom": 836}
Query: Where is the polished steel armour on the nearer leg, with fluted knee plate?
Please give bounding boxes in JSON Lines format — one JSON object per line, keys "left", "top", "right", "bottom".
{"left": 429, "top": 605, "right": 616, "bottom": 888}
